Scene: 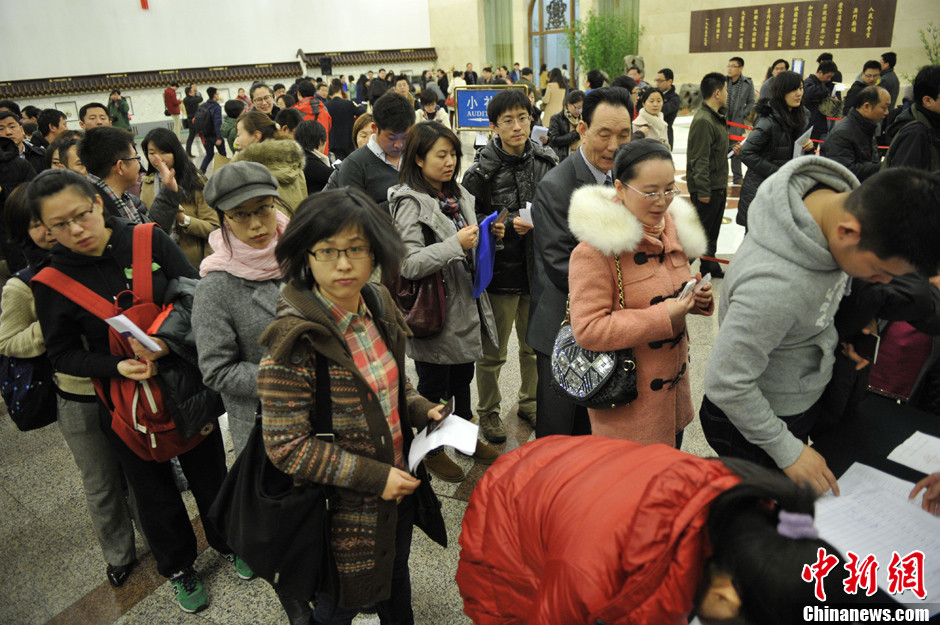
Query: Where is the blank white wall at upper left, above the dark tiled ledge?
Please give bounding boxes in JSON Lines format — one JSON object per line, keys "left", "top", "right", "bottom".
{"left": 0, "top": 0, "right": 434, "bottom": 80}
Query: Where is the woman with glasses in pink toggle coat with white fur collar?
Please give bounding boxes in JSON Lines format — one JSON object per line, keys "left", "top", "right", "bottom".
{"left": 568, "top": 139, "right": 714, "bottom": 448}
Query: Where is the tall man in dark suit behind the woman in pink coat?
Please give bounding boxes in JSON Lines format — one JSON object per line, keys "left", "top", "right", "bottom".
{"left": 526, "top": 87, "right": 633, "bottom": 438}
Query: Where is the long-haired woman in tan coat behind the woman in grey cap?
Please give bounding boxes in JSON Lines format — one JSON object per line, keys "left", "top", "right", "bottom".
{"left": 140, "top": 128, "right": 219, "bottom": 267}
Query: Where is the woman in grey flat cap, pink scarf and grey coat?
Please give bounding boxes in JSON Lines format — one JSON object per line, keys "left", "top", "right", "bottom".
{"left": 193, "top": 162, "right": 288, "bottom": 455}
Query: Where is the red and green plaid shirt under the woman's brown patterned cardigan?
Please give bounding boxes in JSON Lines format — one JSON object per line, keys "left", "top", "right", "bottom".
{"left": 313, "top": 288, "right": 405, "bottom": 470}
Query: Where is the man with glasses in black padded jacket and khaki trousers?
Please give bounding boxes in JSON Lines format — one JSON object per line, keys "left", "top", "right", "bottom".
{"left": 463, "top": 89, "right": 558, "bottom": 443}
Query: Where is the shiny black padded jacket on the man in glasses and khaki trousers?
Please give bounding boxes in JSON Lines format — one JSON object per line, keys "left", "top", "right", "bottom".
{"left": 462, "top": 136, "right": 567, "bottom": 295}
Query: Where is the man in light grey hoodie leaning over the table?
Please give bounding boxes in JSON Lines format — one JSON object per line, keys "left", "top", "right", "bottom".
{"left": 700, "top": 156, "right": 940, "bottom": 494}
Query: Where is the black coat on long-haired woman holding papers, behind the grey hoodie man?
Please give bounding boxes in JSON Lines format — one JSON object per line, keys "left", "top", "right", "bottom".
{"left": 735, "top": 100, "right": 810, "bottom": 227}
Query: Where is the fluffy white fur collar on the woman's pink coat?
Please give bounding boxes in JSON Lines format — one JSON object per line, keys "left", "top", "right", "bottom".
{"left": 568, "top": 185, "right": 708, "bottom": 258}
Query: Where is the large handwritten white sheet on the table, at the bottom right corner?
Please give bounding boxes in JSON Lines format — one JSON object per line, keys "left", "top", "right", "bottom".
{"left": 816, "top": 487, "right": 940, "bottom": 613}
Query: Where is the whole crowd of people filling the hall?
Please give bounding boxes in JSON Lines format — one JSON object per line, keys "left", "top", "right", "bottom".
{"left": 0, "top": 53, "right": 940, "bottom": 624}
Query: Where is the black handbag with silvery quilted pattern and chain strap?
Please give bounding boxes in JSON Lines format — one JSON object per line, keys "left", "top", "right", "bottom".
{"left": 550, "top": 256, "right": 637, "bottom": 408}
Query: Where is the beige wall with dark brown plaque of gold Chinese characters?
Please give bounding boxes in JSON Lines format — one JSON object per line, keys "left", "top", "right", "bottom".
{"left": 640, "top": 0, "right": 940, "bottom": 101}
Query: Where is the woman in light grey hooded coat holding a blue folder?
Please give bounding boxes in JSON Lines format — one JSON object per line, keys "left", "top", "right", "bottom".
{"left": 389, "top": 122, "right": 506, "bottom": 482}
